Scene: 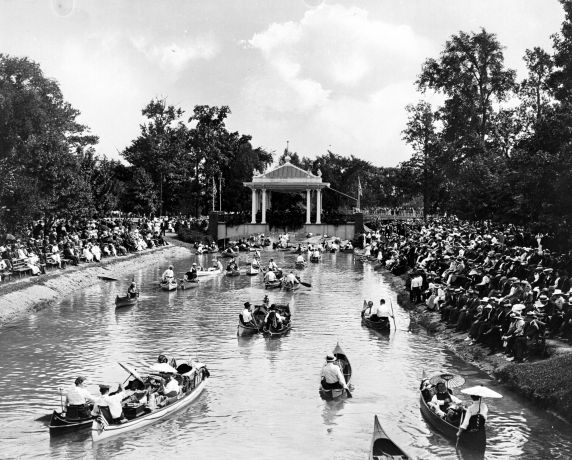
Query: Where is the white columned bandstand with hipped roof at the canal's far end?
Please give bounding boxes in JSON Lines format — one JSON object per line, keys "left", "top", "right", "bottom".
{"left": 243, "top": 161, "right": 330, "bottom": 224}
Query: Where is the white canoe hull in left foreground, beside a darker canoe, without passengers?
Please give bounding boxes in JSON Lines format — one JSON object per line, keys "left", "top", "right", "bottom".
{"left": 91, "top": 378, "right": 208, "bottom": 442}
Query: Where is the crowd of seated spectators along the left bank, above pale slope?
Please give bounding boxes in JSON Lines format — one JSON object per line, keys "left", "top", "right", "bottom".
{"left": 0, "top": 218, "right": 173, "bottom": 280}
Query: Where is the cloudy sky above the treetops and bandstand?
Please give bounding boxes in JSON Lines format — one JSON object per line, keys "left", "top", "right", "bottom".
{"left": 0, "top": 0, "right": 564, "bottom": 166}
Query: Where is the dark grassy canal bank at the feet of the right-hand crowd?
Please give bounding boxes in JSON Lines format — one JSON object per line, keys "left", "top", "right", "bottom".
{"left": 382, "top": 270, "right": 572, "bottom": 422}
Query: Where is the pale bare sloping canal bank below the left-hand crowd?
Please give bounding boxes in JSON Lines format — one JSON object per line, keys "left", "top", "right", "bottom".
{"left": 0, "top": 239, "right": 190, "bottom": 328}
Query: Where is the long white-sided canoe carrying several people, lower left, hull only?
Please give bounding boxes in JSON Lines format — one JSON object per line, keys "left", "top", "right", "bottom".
{"left": 91, "top": 364, "right": 209, "bottom": 442}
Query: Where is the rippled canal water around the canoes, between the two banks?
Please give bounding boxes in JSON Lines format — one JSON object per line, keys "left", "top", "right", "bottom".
{"left": 0, "top": 252, "right": 572, "bottom": 460}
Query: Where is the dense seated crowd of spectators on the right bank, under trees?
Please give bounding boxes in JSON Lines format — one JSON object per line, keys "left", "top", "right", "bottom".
{"left": 361, "top": 218, "right": 572, "bottom": 361}
